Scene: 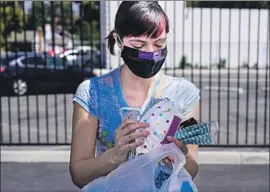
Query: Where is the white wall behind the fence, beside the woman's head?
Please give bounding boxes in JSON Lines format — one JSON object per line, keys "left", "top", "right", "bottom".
{"left": 105, "top": 1, "right": 270, "bottom": 68}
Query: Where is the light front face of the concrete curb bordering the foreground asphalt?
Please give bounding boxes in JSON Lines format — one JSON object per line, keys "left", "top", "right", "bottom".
{"left": 1, "top": 150, "right": 269, "bottom": 165}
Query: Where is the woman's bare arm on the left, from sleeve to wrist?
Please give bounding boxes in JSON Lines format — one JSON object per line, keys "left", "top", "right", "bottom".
{"left": 69, "top": 102, "right": 118, "bottom": 188}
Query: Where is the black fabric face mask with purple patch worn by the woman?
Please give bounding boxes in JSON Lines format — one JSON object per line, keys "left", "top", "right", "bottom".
{"left": 121, "top": 46, "right": 167, "bottom": 78}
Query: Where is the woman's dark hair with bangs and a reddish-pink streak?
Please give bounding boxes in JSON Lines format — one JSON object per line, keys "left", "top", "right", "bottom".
{"left": 106, "top": 1, "right": 169, "bottom": 55}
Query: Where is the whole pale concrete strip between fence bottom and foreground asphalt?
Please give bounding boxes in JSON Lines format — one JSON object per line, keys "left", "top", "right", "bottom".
{"left": 1, "top": 146, "right": 269, "bottom": 165}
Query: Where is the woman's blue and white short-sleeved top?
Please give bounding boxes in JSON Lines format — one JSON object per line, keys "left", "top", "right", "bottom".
{"left": 73, "top": 66, "right": 200, "bottom": 155}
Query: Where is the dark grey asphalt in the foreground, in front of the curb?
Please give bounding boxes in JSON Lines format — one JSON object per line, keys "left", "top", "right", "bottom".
{"left": 1, "top": 163, "right": 269, "bottom": 192}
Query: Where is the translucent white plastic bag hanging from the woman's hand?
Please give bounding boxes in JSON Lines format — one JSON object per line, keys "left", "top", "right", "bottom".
{"left": 82, "top": 143, "right": 196, "bottom": 192}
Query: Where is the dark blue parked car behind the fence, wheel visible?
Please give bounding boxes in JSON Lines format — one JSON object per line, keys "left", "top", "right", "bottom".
{"left": 0, "top": 53, "right": 96, "bottom": 95}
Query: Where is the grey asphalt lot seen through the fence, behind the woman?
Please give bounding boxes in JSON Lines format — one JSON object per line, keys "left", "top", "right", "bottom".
{"left": 0, "top": 70, "right": 270, "bottom": 145}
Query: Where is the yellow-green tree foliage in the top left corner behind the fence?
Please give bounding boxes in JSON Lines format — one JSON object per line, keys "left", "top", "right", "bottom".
{"left": 0, "top": 2, "right": 24, "bottom": 37}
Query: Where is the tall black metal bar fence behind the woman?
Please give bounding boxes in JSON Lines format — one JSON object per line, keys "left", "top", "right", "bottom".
{"left": 0, "top": 1, "right": 270, "bottom": 147}
